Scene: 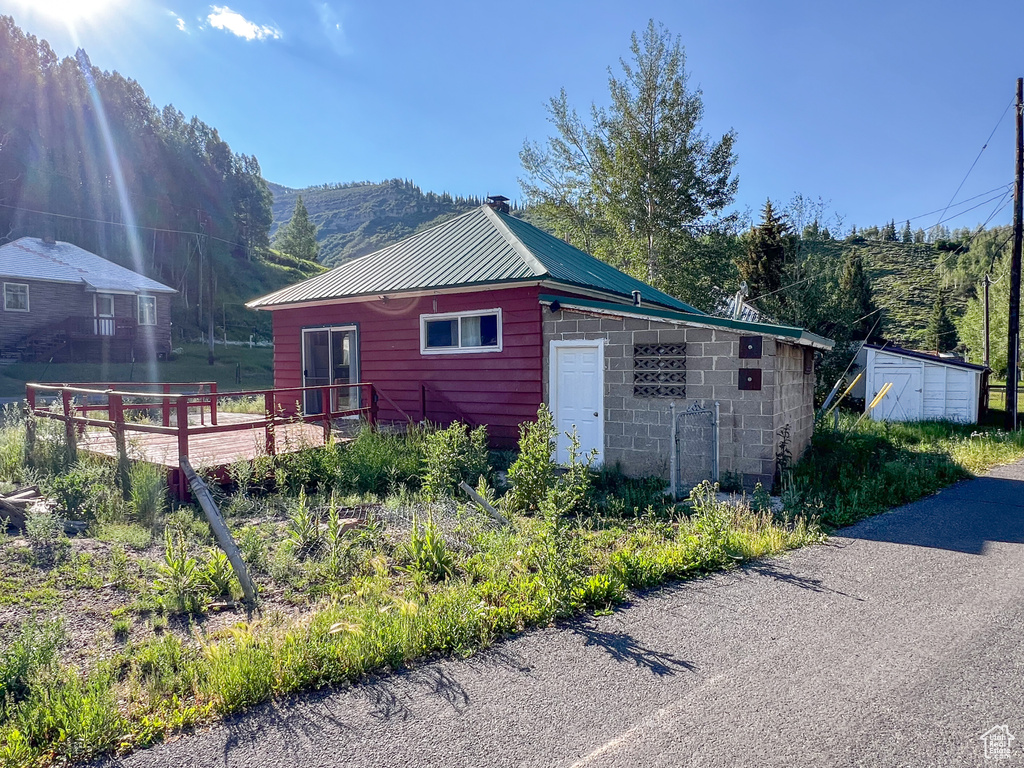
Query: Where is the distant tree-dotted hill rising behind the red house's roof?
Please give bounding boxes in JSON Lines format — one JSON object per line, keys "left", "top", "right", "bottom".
{"left": 269, "top": 179, "right": 482, "bottom": 266}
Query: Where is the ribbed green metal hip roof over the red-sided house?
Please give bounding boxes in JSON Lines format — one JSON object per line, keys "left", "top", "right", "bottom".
{"left": 248, "top": 205, "right": 702, "bottom": 314}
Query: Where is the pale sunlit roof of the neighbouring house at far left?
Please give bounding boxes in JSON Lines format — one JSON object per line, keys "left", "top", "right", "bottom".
{"left": 0, "top": 238, "right": 177, "bottom": 293}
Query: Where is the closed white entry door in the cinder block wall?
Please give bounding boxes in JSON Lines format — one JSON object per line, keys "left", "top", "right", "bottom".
{"left": 549, "top": 339, "right": 604, "bottom": 464}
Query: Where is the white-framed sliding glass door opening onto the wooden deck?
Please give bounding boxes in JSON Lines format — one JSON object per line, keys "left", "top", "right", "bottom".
{"left": 302, "top": 326, "right": 359, "bottom": 415}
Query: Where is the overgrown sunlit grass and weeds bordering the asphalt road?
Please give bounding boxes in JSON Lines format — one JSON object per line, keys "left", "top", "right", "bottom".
{"left": 6, "top": 416, "right": 1024, "bottom": 768}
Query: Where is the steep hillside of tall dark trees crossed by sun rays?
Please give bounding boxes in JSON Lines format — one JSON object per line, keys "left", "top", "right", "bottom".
{"left": 0, "top": 16, "right": 319, "bottom": 338}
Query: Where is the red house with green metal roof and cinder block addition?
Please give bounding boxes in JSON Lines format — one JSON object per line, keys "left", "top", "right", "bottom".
{"left": 249, "top": 199, "right": 830, "bottom": 487}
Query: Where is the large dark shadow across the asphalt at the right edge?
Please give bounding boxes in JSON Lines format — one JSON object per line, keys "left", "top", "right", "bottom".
{"left": 836, "top": 475, "right": 1024, "bottom": 555}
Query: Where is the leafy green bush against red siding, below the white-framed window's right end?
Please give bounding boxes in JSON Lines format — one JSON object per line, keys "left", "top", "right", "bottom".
{"left": 423, "top": 422, "right": 490, "bottom": 499}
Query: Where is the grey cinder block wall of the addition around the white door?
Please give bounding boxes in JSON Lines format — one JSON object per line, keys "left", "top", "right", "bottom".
{"left": 543, "top": 310, "right": 813, "bottom": 487}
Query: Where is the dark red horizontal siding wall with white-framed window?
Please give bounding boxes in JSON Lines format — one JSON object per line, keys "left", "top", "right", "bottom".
{"left": 273, "top": 287, "right": 543, "bottom": 444}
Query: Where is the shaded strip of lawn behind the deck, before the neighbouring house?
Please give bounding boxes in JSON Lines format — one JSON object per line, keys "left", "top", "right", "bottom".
{"left": 0, "top": 344, "right": 273, "bottom": 397}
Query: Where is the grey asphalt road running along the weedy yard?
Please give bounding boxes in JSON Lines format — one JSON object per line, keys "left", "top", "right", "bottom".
{"left": 101, "top": 464, "right": 1024, "bottom": 768}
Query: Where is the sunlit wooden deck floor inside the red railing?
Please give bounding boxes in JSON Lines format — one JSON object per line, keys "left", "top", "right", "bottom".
{"left": 78, "top": 413, "right": 324, "bottom": 469}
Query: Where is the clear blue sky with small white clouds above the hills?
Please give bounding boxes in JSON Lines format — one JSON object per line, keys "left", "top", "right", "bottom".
{"left": 0, "top": 0, "right": 1024, "bottom": 228}
